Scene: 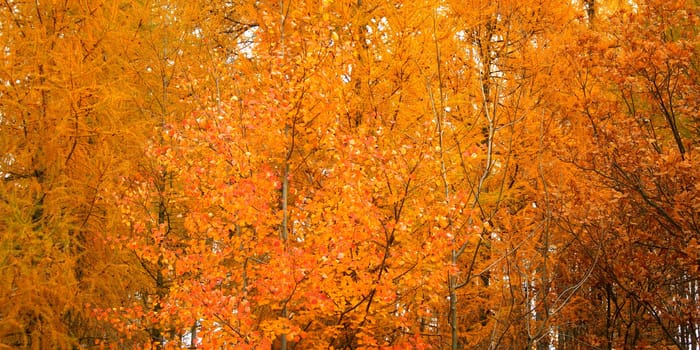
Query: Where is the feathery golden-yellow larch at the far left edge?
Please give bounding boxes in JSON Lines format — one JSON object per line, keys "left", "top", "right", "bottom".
{"left": 0, "top": 1, "right": 155, "bottom": 349}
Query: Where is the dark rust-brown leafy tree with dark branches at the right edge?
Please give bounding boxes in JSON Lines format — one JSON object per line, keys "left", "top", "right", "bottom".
{"left": 557, "top": 1, "right": 698, "bottom": 349}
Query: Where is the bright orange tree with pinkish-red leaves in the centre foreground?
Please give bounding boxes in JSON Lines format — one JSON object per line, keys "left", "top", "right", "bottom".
{"left": 110, "top": 0, "right": 448, "bottom": 347}
